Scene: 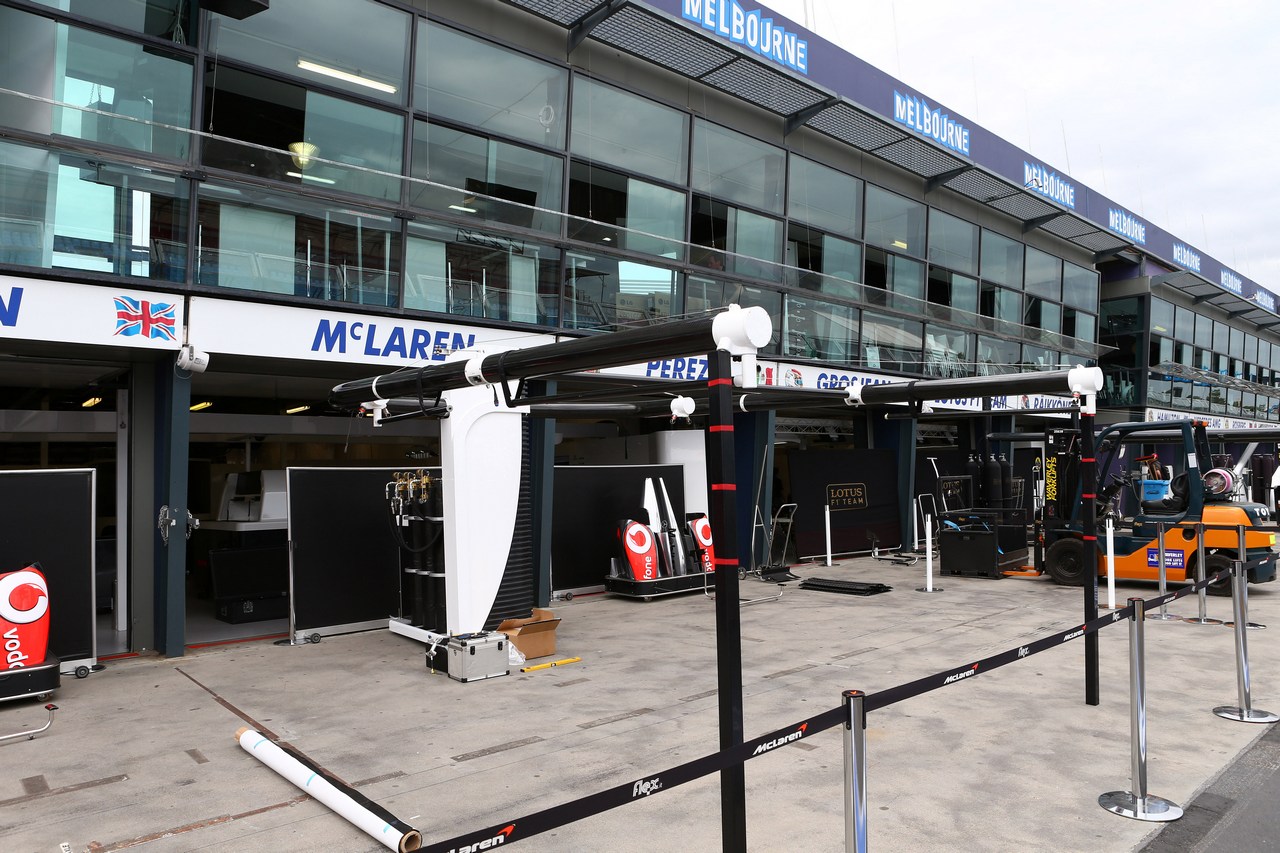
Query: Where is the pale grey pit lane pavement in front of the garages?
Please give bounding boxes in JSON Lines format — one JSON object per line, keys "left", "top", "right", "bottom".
{"left": 0, "top": 557, "right": 1280, "bottom": 853}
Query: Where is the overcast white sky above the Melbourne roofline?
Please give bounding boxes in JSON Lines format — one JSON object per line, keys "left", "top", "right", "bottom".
{"left": 763, "top": 0, "right": 1280, "bottom": 292}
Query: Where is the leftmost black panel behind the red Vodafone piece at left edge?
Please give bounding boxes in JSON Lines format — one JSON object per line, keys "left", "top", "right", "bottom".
{"left": 0, "top": 469, "right": 95, "bottom": 663}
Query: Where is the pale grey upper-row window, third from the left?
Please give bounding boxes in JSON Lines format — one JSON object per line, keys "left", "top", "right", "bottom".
{"left": 414, "top": 18, "right": 568, "bottom": 149}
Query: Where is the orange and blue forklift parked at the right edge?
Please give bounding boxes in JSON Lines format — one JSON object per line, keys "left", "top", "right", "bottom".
{"left": 1036, "top": 419, "right": 1277, "bottom": 596}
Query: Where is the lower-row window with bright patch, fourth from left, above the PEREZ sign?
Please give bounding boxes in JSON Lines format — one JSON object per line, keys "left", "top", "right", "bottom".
{"left": 563, "top": 252, "right": 681, "bottom": 329}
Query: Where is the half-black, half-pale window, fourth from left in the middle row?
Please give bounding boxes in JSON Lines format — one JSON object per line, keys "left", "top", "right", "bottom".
{"left": 568, "top": 163, "right": 685, "bottom": 257}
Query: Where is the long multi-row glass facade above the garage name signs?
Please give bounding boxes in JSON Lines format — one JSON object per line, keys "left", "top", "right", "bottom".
{"left": 12, "top": 0, "right": 1249, "bottom": 394}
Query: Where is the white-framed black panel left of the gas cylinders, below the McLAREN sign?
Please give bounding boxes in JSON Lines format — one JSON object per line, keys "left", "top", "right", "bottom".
{"left": 288, "top": 466, "right": 412, "bottom": 631}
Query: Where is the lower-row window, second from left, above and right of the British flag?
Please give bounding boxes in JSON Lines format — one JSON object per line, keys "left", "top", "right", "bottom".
{"left": 196, "top": 182, "right": 399, "bottom": 307}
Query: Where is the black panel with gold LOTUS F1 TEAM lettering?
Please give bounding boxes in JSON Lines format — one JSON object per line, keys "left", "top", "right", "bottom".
{"left": 787, "top": 450, "right": 911, "bottom": 556}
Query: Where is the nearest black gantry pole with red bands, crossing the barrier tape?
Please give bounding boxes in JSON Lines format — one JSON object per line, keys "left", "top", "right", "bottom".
{"left": 707, "top": 351, "right": 746, "bottom": 853}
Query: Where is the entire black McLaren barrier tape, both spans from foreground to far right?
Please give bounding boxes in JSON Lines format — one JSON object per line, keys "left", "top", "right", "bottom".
{"left": 420, "top": 569, "right": 1231, "bottom": 853}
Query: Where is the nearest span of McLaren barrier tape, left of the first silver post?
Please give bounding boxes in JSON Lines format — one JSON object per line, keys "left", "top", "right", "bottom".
{"left": 419, "top": 707, "right": 849, "bottom": 853}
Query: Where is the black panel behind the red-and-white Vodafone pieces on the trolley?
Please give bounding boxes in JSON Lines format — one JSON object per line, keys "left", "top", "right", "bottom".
{"left": 552, "top": 465, "right": 685, "bottom": 589}
